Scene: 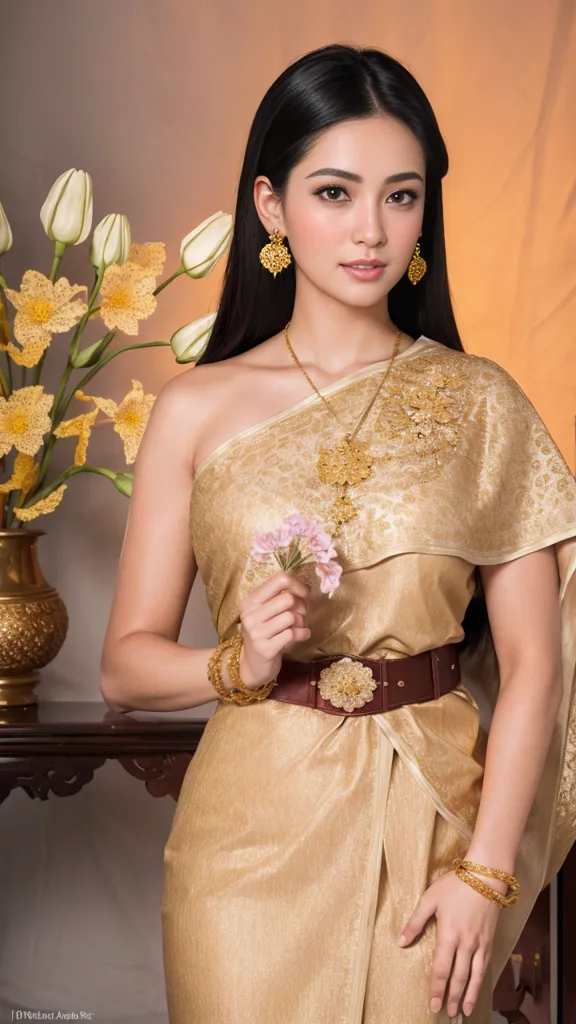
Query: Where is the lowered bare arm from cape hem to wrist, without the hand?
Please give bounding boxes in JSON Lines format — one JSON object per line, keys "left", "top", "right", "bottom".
{"left": 466, "top": 545, "right": 567, "bottom": 880}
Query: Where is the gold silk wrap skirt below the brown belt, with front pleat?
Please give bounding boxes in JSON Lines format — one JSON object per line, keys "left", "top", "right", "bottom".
{"left": 162, "top": 699, "right": 493, "bottom": 1024}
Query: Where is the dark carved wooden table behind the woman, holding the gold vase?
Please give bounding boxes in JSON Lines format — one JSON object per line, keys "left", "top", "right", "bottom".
{"left": 0, "top": 700, "right": 576, "bottom": 1024}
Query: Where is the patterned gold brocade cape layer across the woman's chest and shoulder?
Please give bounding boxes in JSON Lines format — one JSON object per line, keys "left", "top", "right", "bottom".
{"left": 190, "top": 339, "right": 576, "bottom": 614}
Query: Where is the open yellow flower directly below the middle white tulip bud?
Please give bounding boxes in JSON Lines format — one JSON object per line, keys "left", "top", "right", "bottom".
{"left": 99, "top": 261, "right": 157, "bottom": 334}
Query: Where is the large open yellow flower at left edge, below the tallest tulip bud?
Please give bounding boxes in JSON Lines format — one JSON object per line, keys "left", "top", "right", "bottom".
{"left": 6, "top": 270, "right": 88, "bottom": 367}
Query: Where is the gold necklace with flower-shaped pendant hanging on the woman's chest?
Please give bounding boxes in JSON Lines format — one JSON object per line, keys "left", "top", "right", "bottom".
{"left": 284, "top": 321, "right": 403, "bottom": 537}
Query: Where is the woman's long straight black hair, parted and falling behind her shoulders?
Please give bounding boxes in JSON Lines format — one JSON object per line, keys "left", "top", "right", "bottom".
{"left": 198, "top": 44, "right": 486, "bottom": 644}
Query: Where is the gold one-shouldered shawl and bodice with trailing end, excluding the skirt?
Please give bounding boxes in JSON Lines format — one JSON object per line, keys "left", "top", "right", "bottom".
{"left": 191, "top": 336, "right": 576, "bottom": 967}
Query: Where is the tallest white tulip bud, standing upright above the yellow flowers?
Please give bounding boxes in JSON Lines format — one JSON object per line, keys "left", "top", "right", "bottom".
{"left": 40, "top": 167, "right": 92, "bottom": 246}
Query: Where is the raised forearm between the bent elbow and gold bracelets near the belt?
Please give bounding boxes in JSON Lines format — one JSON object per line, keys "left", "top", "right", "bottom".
{"left": 100, "top": 633, "right": 227, "bottom": 712}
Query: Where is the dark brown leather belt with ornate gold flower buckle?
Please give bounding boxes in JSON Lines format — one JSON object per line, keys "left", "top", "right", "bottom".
{"left": 266, "top": 643, "right": 460, "bottom": 715}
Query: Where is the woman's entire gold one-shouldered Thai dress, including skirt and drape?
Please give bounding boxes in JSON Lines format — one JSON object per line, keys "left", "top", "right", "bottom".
{"left": 162, "top": 336, "right": 576, "bottom": 1024}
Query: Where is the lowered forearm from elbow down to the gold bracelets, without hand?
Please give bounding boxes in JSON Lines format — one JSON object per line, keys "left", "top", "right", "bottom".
{"left": 466, "top": 670, "right": 561, "bottom": 881}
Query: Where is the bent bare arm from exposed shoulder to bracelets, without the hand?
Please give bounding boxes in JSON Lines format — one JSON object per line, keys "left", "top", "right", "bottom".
{"left": 100, "top": 367, "right": 217, "bottom": 712}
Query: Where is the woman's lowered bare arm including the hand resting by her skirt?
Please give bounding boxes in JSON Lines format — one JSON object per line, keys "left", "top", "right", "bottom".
{"left": 399, "top": 546, "right": 569, "bottom": 1017}
